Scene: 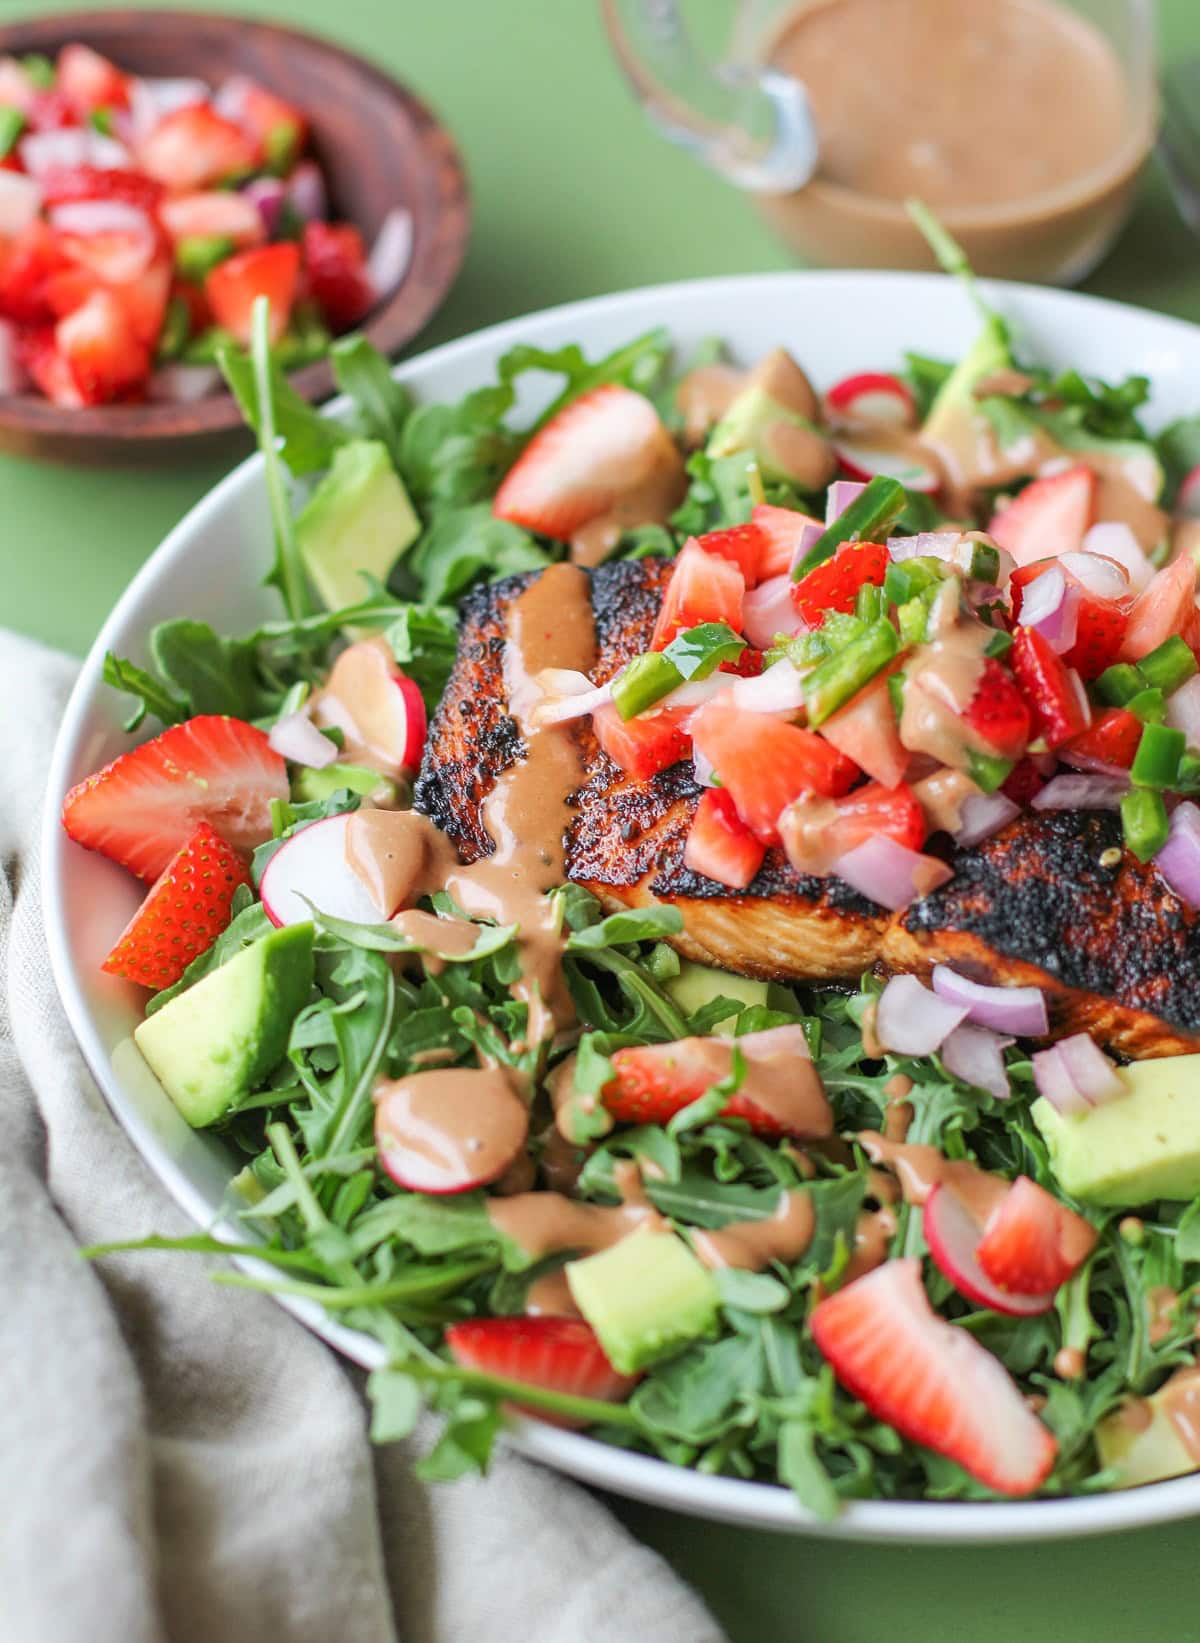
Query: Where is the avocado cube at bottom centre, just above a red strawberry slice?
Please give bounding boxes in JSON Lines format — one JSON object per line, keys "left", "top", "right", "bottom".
{"left": 565, "top": 1227, "right": 717, "bottom": 1375}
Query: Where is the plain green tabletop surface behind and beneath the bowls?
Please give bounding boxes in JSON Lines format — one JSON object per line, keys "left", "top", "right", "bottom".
{"left": 0, "top": 0, "right": 1200, "bottom": 1643}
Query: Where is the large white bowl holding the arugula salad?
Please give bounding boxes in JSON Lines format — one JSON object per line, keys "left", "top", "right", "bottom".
{"left": 43, "top": 273, "right": 1200, "bottom": 1544}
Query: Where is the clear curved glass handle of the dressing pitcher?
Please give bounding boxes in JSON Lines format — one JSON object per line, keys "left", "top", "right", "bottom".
{"left": 600, "top": 0, "right": 817, "bottom": 192}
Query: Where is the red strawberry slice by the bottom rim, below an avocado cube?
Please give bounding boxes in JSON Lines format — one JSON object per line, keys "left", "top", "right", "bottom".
{"left": 445, "top": 1318, "right": 641, "bottom": 1426}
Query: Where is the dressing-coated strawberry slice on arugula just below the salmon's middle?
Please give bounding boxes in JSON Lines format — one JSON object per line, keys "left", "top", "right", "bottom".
{"left": 602, "top": 1027, "right": 812, "bottom": 1139}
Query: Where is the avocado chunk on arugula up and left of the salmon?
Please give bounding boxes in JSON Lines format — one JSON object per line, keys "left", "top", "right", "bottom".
{"left": 296, "top": 439, "right": 421, "bottom": 610}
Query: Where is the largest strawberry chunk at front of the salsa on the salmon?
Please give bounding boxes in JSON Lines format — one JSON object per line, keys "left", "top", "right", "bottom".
{"left": 692, "top": 702, "right": 858, "bottom": 845}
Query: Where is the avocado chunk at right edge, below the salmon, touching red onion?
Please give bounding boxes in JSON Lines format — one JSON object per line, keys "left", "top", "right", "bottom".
{"left": 1031, "top": 1055, "right": 1200, "bottom": 1209}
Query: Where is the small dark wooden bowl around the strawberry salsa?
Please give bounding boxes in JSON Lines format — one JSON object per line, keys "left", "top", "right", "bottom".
{"left": 0, "top": 12, "right": 470, "bottom": 462}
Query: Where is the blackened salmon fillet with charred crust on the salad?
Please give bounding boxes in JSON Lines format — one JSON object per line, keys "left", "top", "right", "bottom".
{"left": 416, "top": 559, "right": 1200, "bottom": 1056}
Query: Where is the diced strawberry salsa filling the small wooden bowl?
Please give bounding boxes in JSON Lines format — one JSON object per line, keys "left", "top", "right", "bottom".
{"left": 0, "top": 43, "right": 411, "bottom": 407}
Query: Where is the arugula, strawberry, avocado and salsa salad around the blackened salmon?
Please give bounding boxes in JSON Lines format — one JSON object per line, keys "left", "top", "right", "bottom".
{"left": 62, "top": 256, "right": 1200, "bottom": 1516}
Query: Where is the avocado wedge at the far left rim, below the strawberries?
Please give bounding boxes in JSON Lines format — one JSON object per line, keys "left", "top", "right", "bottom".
{"left": 133, "top": 923, "right": 312, "bottom": 1129}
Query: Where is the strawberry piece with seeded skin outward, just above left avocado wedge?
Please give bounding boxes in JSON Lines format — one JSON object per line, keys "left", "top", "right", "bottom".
{"left": 100, "top": 822, "right": 250, "bottom": 989}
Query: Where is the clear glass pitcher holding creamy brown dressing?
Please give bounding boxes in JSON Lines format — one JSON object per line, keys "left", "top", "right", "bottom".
{"left": 600, "top": 0, "right": 1157, "bottom": 284}
